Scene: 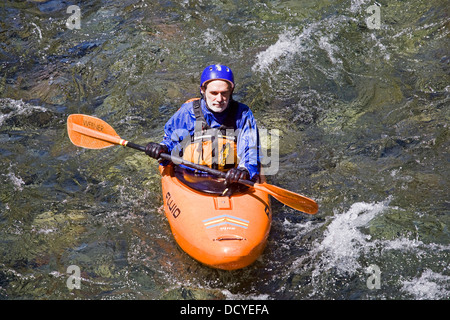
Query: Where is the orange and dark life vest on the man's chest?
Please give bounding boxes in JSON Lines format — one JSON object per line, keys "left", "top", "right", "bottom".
{"left": 182, "top": 98, "right": 238, "bottom": 171}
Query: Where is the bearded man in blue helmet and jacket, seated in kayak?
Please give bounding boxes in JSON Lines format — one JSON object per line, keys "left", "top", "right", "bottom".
{"left": 146, "top": 65, "right": 261, "bottom": 185}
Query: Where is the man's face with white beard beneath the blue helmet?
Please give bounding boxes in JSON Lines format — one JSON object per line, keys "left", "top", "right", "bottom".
{"left": 202, "top": 80, "right": 233, "bottom": 112}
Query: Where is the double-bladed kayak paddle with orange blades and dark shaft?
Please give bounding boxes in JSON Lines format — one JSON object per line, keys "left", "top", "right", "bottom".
{"left": 67, "top": 114, "right": 318, "bottom": 214}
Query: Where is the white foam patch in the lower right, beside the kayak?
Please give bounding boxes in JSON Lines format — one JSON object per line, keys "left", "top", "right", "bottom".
{"left": 284, "top": 197, "right": 450, "bottom": 299}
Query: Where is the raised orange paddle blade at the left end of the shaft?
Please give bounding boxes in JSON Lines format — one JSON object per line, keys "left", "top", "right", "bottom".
{"left": 67, "top": 114, "right": 127, "bottom": 149}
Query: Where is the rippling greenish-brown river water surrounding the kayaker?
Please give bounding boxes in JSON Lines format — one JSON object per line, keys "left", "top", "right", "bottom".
{"left": 0, "top": 0, "right": 450, "bottom": 300}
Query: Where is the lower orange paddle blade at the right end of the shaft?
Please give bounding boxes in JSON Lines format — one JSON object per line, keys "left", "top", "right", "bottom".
{"left": 254, "top": 182, "right": 319, "bottom": 214}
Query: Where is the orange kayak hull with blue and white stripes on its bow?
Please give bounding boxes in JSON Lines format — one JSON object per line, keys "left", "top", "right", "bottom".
{"left": 160, "top": 165, "right": 272, "bottom": 270}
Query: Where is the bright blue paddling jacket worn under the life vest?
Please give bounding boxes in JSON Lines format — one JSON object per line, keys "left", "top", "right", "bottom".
{"left": 162, "top": 99, "right": 261, "bottom": 179}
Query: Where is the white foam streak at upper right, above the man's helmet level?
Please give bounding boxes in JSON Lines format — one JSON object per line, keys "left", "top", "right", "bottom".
{"left": 252, "top": 0, "right": 395, "bottom": 78}
